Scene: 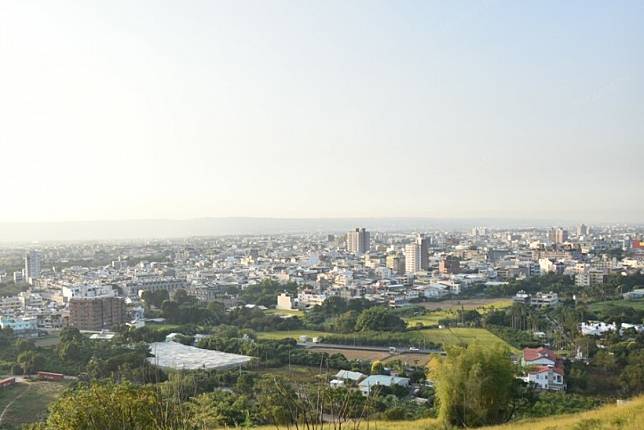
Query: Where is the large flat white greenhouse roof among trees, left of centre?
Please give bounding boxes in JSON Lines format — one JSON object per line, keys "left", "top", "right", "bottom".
{"left": 148, "top": 342, "right": 253, "bottom": 370}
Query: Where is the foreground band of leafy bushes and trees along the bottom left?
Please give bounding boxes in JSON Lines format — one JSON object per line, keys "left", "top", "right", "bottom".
{"left": 31, "top": 371, "right": 430, "bottom": 430}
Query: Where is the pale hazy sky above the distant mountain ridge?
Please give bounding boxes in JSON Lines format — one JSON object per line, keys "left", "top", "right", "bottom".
{"left": 0, "top": 0, "right": 644, "bottom": 222}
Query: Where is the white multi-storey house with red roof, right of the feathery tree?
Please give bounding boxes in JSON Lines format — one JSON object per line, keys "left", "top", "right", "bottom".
{"left": 521, "top": 347, "right": 566, "bottom": 391}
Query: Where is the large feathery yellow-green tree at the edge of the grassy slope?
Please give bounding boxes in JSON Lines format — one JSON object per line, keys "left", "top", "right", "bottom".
{"left": 428, "top": 342, "right": 525, "bottom": 427}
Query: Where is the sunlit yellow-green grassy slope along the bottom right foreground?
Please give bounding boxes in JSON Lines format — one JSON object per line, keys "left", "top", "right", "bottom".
{"left": 247, "top": 396, "right": 644, "bottom": 430}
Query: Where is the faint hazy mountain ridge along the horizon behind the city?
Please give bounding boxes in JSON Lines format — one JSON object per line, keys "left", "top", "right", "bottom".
{"left": 0, "top": 217, "right": 584, "bottom": 243}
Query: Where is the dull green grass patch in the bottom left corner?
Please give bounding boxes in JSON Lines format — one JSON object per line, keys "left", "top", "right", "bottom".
{"left": 0, "top": 381, "right": 67, "bottom": 430}
